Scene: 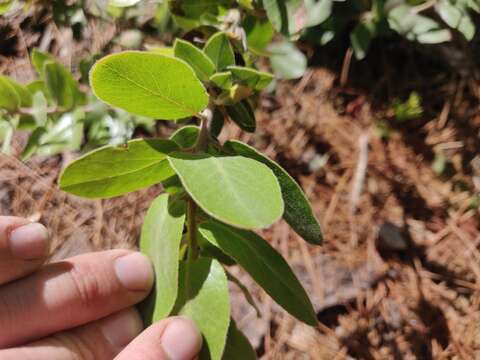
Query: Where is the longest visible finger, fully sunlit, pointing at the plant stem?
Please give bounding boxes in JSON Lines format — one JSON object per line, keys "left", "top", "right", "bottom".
{"left": 0, "top": 250, "right": 153, "bottom": 349}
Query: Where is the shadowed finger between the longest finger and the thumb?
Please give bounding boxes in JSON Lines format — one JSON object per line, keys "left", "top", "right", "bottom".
{"left": 0, "top": 308, "right": 143, "bottom": 360}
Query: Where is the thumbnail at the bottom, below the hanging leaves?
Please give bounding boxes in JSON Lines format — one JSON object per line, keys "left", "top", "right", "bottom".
{"left": 161, "top": 317, "right": 202, "bottom": 360}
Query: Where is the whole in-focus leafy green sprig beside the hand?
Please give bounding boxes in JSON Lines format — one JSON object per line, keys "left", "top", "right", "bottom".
{"left": 59, "top": 32, "right": 322, "bottom": 360}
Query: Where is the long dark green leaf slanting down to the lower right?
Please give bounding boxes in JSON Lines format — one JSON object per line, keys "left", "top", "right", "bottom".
{"left": 199, "top": 220, "right": 317, "bottom": 326}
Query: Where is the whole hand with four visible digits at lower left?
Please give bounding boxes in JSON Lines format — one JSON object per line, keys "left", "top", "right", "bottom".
{"left": 0, "top": 216, "right": 202, "bottom": 360}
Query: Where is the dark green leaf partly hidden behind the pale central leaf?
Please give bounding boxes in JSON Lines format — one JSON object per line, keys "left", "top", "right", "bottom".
{"left": 225, "top": 140, "right": 323, "bottom": 245}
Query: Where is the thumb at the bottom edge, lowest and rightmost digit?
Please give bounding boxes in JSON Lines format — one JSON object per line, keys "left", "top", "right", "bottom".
{"left": 115, "top": 317, "right": 202, "bottom": 360}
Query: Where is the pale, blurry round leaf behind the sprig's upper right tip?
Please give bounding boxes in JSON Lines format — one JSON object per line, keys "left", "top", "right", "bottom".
{"left": 269, "top": 41, "right": 307, "bottom": 79}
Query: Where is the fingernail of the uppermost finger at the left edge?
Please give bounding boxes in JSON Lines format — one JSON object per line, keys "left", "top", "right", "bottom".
{"left": 8, "top": 223, "right": 49, "bottom": 260}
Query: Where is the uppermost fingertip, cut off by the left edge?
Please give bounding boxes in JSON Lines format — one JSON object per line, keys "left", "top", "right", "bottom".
{"left": 0, "top": 216, "right": 49, "bottom": 285}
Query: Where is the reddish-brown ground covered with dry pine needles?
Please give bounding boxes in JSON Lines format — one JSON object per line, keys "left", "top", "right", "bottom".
{"left": 0, "top": 7, "right": 480, "bottom": 359}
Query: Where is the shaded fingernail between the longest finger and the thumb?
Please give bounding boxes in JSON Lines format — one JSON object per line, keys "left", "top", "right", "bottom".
{"left": 99, "top": 309, "right": 143, "bottom": 349}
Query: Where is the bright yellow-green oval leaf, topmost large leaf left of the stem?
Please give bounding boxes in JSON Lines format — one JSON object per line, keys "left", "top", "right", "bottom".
{"left": 90, "top": 51, "right": 208, "bottom": 120}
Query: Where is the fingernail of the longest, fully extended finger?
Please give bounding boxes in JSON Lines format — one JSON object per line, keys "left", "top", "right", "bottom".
{"left": 114, "top": 252, "right": 153, "bottom": 290}
